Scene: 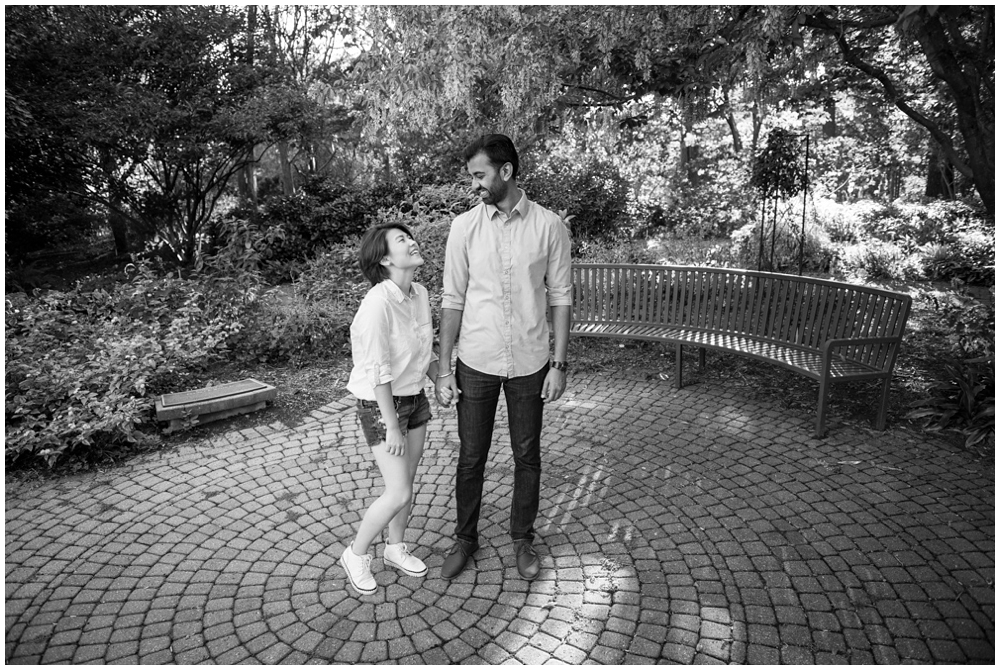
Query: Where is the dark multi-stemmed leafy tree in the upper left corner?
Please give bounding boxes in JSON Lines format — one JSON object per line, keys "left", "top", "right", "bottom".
{"left": 6, "top": 6, "right": 315, "bottom": 262}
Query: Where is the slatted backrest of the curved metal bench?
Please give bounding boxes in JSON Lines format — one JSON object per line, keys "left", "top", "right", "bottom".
{"left": 573, "top": 263, "right": 910, "bottom": 369}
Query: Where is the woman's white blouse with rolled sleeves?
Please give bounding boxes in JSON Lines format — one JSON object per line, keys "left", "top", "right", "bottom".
{"left": 347, "top": 279, "right": 437, "bottom": 400}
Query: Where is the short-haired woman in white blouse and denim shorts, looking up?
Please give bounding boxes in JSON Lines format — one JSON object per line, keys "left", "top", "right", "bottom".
{"left": 340, "top": 223, "right": 448, "bottom": 595}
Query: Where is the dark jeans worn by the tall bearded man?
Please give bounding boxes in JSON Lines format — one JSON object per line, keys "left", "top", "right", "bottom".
{"left": 455, "top": 360, "right": 549, "bottom": 549}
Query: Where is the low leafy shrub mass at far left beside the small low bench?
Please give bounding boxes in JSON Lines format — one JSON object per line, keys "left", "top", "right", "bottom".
{"left": 4, "top": 266, "right": 248, "bottom": 466}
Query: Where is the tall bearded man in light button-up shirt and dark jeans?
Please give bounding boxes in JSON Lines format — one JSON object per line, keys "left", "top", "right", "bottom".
{"left": 435, "top": 135, "right": 572, "bottom": 579}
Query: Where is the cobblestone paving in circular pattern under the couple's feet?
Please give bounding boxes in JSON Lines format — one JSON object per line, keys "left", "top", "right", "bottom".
{"left": 5, "top": 375, "right": 995, "bottom": 664}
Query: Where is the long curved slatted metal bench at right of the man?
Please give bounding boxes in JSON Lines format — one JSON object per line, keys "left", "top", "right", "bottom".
{"left": 570, "top": 263, "right": 911, "bottom": 437}
